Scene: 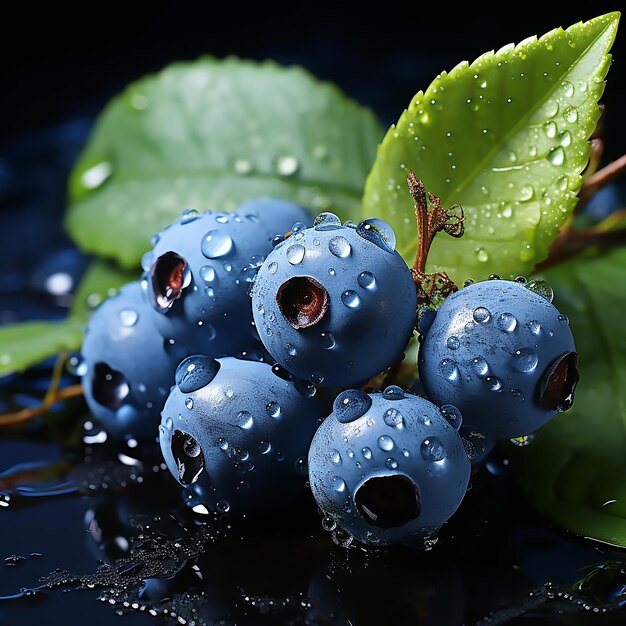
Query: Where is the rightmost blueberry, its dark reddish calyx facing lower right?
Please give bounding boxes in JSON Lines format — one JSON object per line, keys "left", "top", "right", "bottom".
{"left": 418, "top": 280, "right": 578, "bottom": 438}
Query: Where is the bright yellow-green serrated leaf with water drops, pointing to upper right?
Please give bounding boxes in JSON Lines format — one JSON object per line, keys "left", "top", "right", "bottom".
{"left": 363, "top": 13, "right": 619, "bottom": 283}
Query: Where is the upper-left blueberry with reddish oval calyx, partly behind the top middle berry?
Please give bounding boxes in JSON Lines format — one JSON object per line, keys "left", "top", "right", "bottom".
{"left": 142, "top": 199, "right": 310, "bottom": 356}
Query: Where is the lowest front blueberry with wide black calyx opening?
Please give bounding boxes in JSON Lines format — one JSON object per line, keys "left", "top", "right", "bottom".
{"left": 309, "top": 387, "right": 470, "bottom": 548}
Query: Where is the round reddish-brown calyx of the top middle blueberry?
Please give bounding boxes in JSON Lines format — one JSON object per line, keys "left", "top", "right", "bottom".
{"left": 276, "top": 276, "right": 330, "bottom": 330}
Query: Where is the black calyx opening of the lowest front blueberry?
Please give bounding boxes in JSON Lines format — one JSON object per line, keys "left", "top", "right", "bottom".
{"left": 354, "top": 474, "right": 422, "bottom": 528}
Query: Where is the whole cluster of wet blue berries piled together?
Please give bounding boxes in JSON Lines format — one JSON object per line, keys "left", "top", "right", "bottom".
{"left": 83, "top": 194, "right": 578, "bottom": 546}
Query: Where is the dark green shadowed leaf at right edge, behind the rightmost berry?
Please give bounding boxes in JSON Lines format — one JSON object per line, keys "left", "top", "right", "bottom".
{"left": 517, "top": 248, "right": 626, "bottom": 546}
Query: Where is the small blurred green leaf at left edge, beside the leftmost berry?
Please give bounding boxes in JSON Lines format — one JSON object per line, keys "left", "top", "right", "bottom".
{"left": 0, "top": 261, "right": 133, "bottom": 376}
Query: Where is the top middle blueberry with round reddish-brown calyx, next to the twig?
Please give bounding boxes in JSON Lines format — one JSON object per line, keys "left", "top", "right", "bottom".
{"left": 251, "top": 213, "right": 417, "bottom": 387}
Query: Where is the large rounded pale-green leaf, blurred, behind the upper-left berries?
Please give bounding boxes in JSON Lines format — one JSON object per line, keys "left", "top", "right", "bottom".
{"left": 67, "top": 58, "right": 383, "bottom": 267}
